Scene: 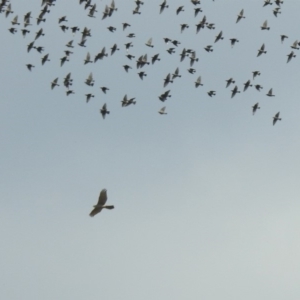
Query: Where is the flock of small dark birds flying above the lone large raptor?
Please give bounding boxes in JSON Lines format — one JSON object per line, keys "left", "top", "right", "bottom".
{"left": 0, "top": 0, "right": 292, "bottom": 125}
